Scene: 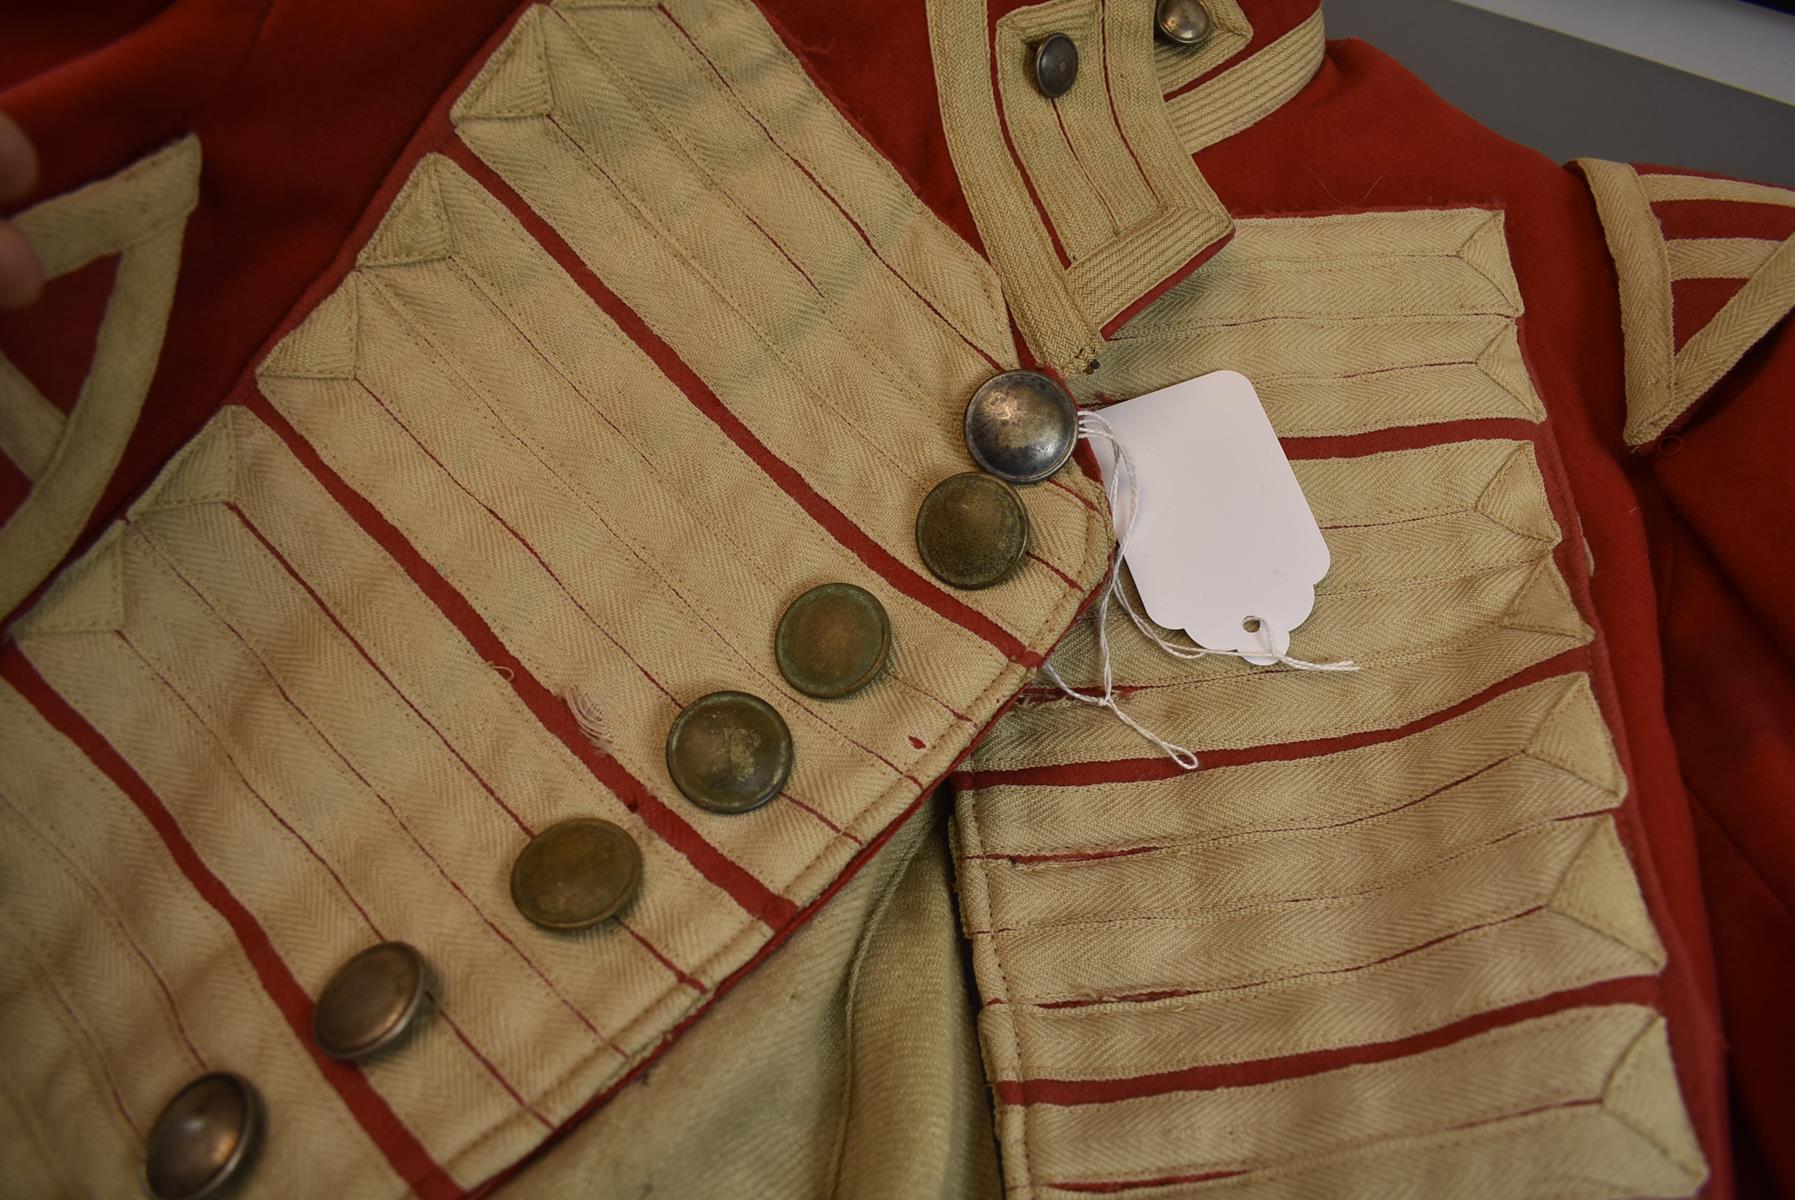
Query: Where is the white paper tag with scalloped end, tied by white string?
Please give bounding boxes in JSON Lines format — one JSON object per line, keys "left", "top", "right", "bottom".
{"left": 1091, "top": 371, "right": 1328, "bottom": 665}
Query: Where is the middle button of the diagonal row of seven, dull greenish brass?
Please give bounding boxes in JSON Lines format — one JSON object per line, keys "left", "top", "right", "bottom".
{"left": 668, "top": 692, "right": 793, "bottom": 813}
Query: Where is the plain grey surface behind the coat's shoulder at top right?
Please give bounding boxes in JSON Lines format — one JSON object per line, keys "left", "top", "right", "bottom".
{"left": 1323, "top": 0, "right": 1795, "bottom": 187}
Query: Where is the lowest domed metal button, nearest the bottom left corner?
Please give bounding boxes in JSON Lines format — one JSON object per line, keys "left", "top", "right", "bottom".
{"left": 144, "top": 1071, "right": 262, "bottom": 1200}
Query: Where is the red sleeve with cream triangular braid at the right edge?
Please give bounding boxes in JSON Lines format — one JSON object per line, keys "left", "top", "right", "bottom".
{"left": 1580, "top": 160, "right": 1795, "bottom": 1195}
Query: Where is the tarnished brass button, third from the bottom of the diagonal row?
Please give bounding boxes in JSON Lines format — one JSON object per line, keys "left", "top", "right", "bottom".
{"left": 512, "top": 816, "right": 643, "bottom": 929}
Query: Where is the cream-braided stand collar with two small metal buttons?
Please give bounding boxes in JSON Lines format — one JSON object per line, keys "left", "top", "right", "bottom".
{"left": 928, "top": 0, "right": 1323, "bottom": 371}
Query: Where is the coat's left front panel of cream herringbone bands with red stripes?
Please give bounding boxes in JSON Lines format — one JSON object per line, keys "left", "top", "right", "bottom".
{"left": 0, "top": 2, "right": 1109, "bottom": 1196}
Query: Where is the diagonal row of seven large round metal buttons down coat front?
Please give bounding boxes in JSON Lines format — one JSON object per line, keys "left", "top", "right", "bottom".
{"left": 144, "top": 358, "right": 1091, "bottom": 1200}
